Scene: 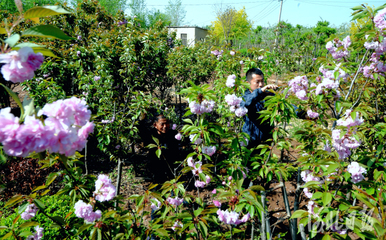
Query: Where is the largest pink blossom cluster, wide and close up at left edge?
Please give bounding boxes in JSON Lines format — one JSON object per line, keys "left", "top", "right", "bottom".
{"left": 0, "top": 97, "right": 94, "bottom": 157}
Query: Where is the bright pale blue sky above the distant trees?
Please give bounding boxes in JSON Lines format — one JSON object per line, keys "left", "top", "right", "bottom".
{"left": 145, "top": 0, "right": 385, "bottom": 27}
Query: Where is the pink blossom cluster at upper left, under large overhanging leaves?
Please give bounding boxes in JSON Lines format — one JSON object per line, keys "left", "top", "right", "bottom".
{"left": 0, "top": 47, "right": 44, "bottom": 83}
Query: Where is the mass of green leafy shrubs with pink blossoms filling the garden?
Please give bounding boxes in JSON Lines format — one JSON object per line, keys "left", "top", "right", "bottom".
{"left": 0, "top": 0, "right": 386, "bottom": 239}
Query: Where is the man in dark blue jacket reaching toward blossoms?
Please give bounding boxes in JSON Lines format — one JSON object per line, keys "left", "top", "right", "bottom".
{"left": 242, "top": 68, "right": 277, "bottom": 149}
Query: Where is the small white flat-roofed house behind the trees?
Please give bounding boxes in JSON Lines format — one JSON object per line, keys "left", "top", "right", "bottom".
{"left": 168, "top": 26, "right": 208, "bottom": 46}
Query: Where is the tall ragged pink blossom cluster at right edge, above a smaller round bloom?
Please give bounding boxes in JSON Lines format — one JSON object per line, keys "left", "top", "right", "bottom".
{"left": 332, "top": 109, "right": 363, "bottom": 159}
